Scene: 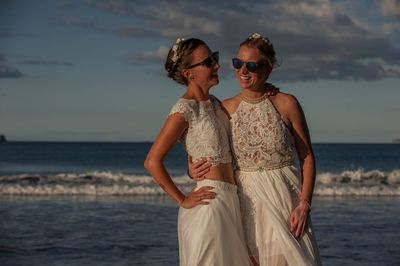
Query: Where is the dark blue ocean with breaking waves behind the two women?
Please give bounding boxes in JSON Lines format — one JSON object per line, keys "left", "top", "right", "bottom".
{"left": 0, "top": 142, "right": 400, "bottom": 265}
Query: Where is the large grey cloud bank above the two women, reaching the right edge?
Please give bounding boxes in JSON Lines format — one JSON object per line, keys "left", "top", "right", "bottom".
{"left": 80, "top": 0, "right": 400, "bottom": 81}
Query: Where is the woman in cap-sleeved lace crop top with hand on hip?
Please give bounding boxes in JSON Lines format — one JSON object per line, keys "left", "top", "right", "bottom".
{"left": 144, "top": 38, "right": 251, "bottom": 266}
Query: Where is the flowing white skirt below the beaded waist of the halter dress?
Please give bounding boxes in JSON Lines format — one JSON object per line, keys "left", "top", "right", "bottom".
{"left": 235, "top": 166, "right": 321, "bottom": 266}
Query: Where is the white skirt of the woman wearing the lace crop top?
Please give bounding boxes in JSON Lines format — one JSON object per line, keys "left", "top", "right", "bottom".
{"left": 178, "top": 179, "right": 250, "bottom": 266}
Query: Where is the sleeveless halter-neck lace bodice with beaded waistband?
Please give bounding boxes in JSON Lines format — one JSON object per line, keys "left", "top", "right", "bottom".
{"left": 231, "top": 97, "right": 295, "bottom": 171}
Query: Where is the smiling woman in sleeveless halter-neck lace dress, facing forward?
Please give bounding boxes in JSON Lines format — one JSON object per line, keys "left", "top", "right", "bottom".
{"left": 189, "top": 33, "right": 321, "bottom": 266}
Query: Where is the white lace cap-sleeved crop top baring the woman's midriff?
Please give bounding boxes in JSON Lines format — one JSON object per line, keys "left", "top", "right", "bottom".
{"left": 169, "top": 95, "right": 232, "bottom": 165}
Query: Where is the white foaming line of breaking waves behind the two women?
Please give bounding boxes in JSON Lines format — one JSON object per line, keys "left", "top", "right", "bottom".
{"left": 0, "top": 169, "right": 400, "bottom": 196}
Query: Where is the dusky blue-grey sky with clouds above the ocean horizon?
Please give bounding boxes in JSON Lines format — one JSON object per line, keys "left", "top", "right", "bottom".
{"left": 0, "top": 0, "right": 400, "bottom": 143}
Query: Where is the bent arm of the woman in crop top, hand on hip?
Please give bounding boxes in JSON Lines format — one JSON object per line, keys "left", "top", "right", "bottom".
{"left": 144, "top": 114, "right": 215, "bottom": 208}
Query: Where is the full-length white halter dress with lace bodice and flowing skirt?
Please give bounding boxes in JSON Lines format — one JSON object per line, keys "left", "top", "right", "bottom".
{"left": 231, "top": 97, "right": 320, "bottom": 266}
